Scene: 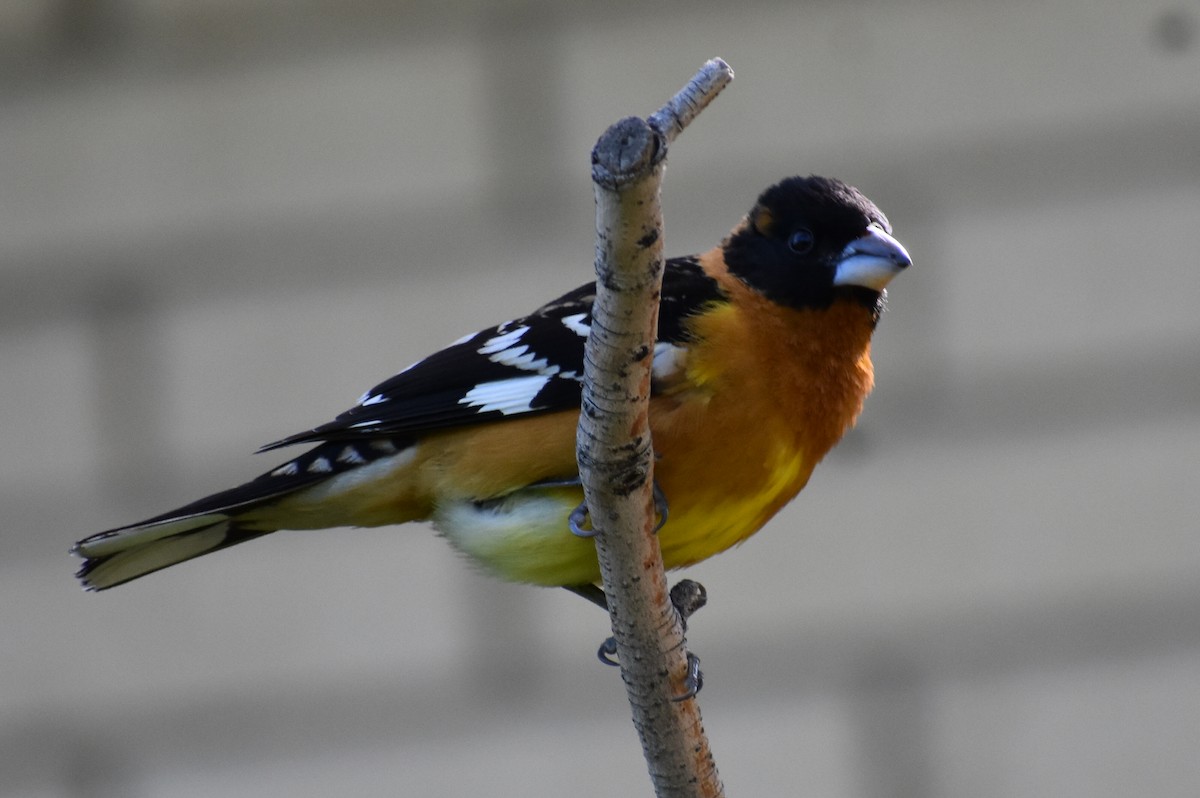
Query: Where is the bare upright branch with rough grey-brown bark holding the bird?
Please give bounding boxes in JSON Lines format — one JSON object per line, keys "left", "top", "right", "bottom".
{"left": 576, "top": 59, "right": 733, "bottom": 798}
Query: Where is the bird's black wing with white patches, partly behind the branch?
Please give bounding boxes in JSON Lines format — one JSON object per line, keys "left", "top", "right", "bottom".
{"left": 260, "top": 258, "right": 724, "bottom": 451}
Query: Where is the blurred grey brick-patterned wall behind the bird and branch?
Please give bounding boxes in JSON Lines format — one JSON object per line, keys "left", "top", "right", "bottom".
{"left": 0, "top": 0, "right": 1200, "bottom": 798}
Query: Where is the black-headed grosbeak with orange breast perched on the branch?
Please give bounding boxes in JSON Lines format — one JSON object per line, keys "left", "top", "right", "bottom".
{"left": 73, "top": 176, "right": 911, "bottom": 592}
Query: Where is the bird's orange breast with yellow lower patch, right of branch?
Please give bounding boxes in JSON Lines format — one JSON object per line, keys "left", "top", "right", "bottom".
{"left": 650, "top": 266, "right": 872, "bottom": 568}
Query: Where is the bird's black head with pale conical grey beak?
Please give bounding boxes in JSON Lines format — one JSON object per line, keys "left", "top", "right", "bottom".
{"left": 724, "top": 176, "right": 912, "bottom": 308}
